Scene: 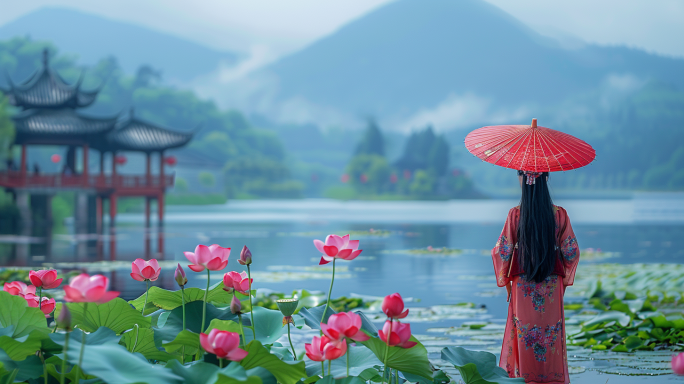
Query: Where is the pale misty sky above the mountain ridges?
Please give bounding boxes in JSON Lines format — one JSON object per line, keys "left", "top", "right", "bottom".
{"left": 0, "top": 0, "right": 684, "bottom": 62}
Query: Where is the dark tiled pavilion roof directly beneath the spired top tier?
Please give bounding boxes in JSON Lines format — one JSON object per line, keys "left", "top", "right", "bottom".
{"left": 12, "top": 108, "right": 117, "bottom": 144}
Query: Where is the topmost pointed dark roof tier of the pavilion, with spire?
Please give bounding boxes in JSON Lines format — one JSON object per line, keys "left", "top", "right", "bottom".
{"left": 3, "top": 49, "right": 99, "bottom": 109}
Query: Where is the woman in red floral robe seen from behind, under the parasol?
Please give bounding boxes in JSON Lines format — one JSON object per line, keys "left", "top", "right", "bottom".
{"left": 492, "top": 171, "right": 579, "bottom": 384}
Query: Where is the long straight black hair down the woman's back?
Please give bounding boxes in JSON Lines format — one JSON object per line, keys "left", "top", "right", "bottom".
{"left": 518, "top": 171, "right": 557, "bottom": 283}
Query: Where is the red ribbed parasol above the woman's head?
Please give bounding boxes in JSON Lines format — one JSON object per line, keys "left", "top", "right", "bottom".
{"left": 465, "top": 119, "right": 596, "bottom": 173}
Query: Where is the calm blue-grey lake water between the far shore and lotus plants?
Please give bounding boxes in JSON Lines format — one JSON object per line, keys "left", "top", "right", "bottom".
{"left": 0, "top": 194, "right": 684, "bottom": 383}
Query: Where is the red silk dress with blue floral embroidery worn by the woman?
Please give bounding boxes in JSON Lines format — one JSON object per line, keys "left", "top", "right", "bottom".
{"left": 492, "top": 207, "right": 580, "bottom": 384}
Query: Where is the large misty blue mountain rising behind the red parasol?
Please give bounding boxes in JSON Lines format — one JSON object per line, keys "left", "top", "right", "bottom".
{"left": 230, "top": 0, "right": 684, "bottom": 130}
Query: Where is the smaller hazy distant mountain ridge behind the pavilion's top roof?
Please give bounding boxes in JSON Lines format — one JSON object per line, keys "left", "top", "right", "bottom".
{"left": 0, "top": 8, "right": 239, "bottom": 82}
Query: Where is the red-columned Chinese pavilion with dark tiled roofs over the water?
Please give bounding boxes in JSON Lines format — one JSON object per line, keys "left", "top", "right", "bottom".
{"left": 0, "top": 50, "right": 193, "bottom": 257}
